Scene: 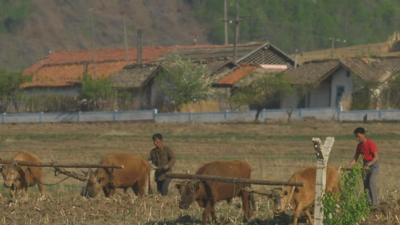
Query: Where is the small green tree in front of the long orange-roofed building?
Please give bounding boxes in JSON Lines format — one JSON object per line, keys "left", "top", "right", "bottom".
{"left": 80, "top": 74, "right": 113, "bottom": 110}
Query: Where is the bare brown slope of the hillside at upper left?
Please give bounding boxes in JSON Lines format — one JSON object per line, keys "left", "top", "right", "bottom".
{"left": 0, "top": 0, "right": 205, "bottom": 69}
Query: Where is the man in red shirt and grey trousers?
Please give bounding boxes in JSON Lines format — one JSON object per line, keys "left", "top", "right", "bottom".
{"left": 350, "top": 127, "right": 379, "bottom": 208}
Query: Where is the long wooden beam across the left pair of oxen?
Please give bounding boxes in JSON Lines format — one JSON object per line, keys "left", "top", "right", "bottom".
{"left": 0, "top": 160, "right": 124, "bottom": 169}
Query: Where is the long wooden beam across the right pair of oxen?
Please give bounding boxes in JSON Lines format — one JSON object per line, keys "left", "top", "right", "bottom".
{"left": 166, "top": 173, "right": 303, "bottom": 187}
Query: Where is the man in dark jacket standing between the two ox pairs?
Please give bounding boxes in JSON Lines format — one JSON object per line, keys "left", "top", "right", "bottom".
{"left": 149, "top": 133, "right": 175, "bottom": 196}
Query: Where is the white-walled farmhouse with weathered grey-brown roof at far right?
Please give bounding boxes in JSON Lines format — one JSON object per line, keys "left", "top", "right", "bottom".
{"left": 281, "top": 57, "right": 400, "bottom": 110}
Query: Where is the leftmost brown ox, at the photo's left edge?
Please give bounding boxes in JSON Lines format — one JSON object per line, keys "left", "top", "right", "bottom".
{"left": 1, "top": 152, "right": 44, "bottom": 198}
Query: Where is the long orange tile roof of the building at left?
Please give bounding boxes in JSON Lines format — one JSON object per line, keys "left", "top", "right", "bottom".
{"left": 22, "top": 45, "right": 236, "bottom": 88}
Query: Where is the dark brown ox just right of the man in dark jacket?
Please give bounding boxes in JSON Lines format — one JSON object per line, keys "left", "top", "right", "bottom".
{"left": 176, "top": 161, "right": 254, "bottom": 224}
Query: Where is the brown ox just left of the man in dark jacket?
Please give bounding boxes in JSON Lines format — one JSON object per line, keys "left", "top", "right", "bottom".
{"left": 82, "top": 153, "right": 151, "bottom": 197}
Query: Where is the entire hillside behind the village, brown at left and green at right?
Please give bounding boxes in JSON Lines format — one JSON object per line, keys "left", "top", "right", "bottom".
{"left": 0, "top": 0, "right": 400, "bottom": 69}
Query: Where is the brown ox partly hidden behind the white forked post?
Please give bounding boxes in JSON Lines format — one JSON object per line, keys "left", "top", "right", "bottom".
{"left": 273, "top": 166, "right": 340, "bottom": 225}
